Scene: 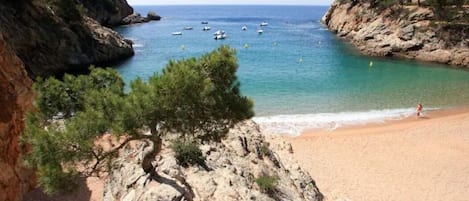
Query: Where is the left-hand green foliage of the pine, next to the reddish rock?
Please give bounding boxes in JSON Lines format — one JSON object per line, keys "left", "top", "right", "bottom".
{"left": 22, "top": 68, "right": 130, "bottom": 194}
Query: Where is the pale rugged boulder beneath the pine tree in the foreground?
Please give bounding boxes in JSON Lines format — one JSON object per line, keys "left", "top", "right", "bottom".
{"left": 104, "top": 121, "right": 323, "bottom": 201}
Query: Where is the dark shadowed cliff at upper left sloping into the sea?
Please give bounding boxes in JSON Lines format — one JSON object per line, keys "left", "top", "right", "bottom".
{"left": 0, "top": 0, "right": 134, "bottom": 77}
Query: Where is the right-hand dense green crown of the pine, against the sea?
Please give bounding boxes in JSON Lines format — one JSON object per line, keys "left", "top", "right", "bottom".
{"left": 129, "top": 46, "right": 254, "bottom": 140}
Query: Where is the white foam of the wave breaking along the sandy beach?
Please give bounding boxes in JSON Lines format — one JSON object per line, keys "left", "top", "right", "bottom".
{"left": 253, "top": 108, "right": 430, "bottom": 136}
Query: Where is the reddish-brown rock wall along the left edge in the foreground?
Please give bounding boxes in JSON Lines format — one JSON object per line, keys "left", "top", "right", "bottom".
{"left": 0, "top": 34, "right": 34, "bottom": 201}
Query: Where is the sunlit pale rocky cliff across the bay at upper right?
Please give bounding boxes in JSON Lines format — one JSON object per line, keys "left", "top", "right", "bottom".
{"left": 322, "top": 1, "right": 469, "bottom": 67}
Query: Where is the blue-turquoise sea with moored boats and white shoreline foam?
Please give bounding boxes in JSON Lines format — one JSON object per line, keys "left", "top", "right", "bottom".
{"left": 115, "top": 5, "right": 469, "bottom": 135}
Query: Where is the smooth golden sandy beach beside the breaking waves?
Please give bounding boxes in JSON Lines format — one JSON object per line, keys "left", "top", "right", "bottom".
{"left": 284, "top": 109, "right": 469, "bottom": 201}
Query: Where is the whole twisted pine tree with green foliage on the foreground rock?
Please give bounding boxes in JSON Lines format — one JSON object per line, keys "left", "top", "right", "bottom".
{"left": 23, "top": 46, "right": 253, "bottom": 194}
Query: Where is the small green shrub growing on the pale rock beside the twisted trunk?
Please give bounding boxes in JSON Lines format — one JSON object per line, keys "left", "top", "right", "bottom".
{"left": 171, "top": 140, "right": 205, "bottom": 167}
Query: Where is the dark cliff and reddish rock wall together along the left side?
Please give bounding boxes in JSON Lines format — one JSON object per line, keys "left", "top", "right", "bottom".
{"left": 0, "top": 0, "right": 139, "bottom": 201}
